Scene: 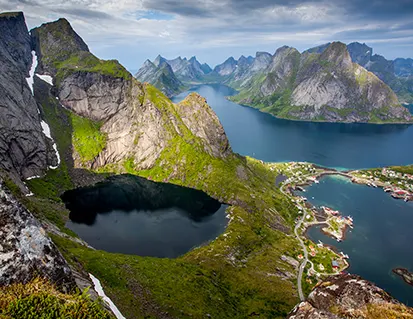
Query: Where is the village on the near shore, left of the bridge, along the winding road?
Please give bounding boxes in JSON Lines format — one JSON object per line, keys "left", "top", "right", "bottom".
{"left": 269, "top": 162, "right": 353, "bottom": 288}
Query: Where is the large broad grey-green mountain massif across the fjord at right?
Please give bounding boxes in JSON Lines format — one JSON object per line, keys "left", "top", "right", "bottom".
{"left": 233, "top": 42, "right": 413, "bottom": 123}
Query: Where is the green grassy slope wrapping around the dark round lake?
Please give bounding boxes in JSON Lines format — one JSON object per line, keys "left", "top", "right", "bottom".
{"left": 25, "top": 79, "right": 298, "bottom": 318}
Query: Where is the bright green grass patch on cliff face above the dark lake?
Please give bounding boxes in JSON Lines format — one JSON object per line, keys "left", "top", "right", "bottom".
{"left": 70, "top": 113, "right": 107, "bottom": 163}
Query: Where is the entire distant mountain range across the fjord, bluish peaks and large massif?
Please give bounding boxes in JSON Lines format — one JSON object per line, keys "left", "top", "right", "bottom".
{"left": 136, "top": 42, "right": 413, "bottom": 123}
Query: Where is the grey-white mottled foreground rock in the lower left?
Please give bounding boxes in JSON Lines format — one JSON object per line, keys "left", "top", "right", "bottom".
{"left": 0, "top": 180, "right": 76, "bottom": 292}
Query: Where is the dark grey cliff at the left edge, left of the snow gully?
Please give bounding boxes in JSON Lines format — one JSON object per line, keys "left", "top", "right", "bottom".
{"left": 0, "top": 12, "right": 57, "bottom": 187}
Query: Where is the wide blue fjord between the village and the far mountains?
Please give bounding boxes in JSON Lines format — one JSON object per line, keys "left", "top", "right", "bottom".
{"left": 173, "top": 85, "right": 413, "bottom": 169}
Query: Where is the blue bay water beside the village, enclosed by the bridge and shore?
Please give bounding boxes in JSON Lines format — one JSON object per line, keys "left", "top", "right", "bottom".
{"left": 302, "top": 176, "right": 413, "bottom": 306}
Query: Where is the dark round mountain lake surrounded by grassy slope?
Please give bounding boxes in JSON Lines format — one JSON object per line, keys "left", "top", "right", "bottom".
{"left": 62, "top": 175, "right": 227, "bottom": 258}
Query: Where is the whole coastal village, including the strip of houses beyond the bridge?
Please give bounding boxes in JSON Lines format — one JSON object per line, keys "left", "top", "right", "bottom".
{"left": 267, "top": 162, "right": 413, "bottom": 296}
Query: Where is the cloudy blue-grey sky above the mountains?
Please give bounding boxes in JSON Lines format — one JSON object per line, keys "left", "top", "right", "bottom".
{"left": 0, "top": 0, "right": 413, "bottom": 70}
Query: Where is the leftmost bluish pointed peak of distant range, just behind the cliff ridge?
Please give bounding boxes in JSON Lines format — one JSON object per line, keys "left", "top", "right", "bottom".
{"left": 135, "top": 56, "right": 184, "bottom": 97}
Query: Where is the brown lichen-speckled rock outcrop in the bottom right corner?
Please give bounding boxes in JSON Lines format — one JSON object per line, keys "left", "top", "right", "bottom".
{"left": 288, "top": 275, "right": 413, "bottom": 319}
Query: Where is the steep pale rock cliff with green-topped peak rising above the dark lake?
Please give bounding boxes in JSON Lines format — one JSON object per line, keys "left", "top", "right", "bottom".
{"left": 34, "top": 19, "right": 229, "bottom": 176}
